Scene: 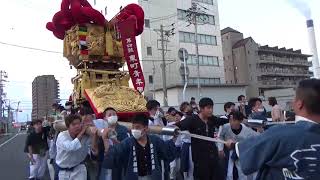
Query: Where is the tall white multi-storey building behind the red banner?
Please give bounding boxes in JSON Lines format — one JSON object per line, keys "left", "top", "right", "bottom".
{"left": 86, "top": 0, "right": 245, "bottom": 111}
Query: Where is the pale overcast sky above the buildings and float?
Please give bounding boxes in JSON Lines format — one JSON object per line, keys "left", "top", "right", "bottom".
{"left": 0, "top": 0, "right": 320, "bottom": 121}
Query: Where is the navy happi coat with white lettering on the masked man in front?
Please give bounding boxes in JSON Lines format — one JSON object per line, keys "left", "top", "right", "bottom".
{"left": 102, "top": 135, "right": 177, "bottom": 180}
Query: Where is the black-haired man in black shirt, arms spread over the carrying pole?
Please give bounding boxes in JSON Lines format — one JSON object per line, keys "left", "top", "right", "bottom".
{"left": 176, "top": 98, "right": 228, "bottom": 180}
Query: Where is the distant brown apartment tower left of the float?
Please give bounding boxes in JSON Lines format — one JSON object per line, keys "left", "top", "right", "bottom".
{"left": 32, "top": 75, "right": 59, "bottom": 120}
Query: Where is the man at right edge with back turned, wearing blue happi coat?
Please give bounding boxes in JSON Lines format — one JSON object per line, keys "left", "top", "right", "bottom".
{"left": 227, "top": 79, "right": 320, "bottom": 180}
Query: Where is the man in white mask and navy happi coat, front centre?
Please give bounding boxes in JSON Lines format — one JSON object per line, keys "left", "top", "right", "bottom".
{"left": 102, "top": 114, "right": 176, "bottom": 180}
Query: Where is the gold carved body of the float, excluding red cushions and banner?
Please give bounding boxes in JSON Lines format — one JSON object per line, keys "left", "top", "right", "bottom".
{"left": 67, "top": 24, "right": 146, "bottom": 113}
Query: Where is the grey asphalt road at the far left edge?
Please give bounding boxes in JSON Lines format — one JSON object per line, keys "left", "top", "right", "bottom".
{"left": 0, "top": 132, "right": 47, "bottom": 180}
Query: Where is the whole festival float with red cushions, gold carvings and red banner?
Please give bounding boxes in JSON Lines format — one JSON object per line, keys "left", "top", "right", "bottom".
{"left": 46, "top": 0, "right": 146, "bottom": 119}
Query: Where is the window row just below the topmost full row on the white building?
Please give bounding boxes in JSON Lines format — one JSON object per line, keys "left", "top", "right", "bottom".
{"left": 179, "top": 31, "right": 217, "bottom": 46}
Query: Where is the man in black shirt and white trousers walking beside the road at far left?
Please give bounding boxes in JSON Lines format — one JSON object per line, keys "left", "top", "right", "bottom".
{"left": 25, "top": 120, "right": 50, "bottom": 180}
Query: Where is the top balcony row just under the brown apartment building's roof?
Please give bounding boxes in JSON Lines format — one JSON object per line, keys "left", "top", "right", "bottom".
{"left": 258, "top": 56, "right": 312, "bottom": 67}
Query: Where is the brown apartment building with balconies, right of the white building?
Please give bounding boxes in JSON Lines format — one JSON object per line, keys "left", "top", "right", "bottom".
{"left": 221, "top": 27, "right": 312, "bottom": 97}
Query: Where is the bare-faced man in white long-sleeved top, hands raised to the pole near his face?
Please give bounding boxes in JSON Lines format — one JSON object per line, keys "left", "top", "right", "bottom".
{"left": 56, "top": 115, "right": 98, "bottom": 180}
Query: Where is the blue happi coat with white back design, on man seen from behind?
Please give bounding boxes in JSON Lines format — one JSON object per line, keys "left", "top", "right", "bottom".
{"left": 238, "top": 120, "right": 320, "bottom": 180}
